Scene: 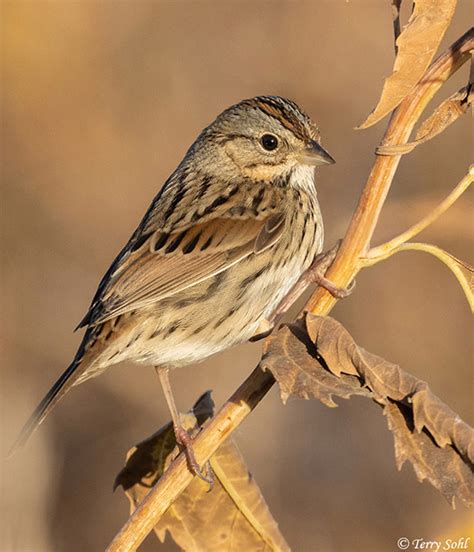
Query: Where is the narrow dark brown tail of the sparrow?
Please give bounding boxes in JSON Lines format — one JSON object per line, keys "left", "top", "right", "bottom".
{"left": 9, "top": 358, "right": 82, "bottom": 456}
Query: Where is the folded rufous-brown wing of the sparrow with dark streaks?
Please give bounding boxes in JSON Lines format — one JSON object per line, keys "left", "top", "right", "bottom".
{"left": 86, "top": 213, "right": 284, "bottom": 324}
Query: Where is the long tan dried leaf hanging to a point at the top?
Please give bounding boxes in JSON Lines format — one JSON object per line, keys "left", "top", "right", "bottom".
{"left": 358, "top": 0, "right": 456, "bottom": 129}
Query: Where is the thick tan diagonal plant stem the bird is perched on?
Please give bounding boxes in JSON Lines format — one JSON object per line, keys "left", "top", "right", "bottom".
{"left": 107, "top": 30, "right": 474, "bottom": 552}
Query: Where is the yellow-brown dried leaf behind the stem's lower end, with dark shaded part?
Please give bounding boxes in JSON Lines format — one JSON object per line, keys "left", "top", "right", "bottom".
{"left": 115, "top": 393, "right": 290, "bottom": 552}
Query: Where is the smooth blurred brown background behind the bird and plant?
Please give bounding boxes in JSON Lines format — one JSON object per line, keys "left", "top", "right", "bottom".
{"left": 0, "top": 0, "right": 474, "bottom": 552}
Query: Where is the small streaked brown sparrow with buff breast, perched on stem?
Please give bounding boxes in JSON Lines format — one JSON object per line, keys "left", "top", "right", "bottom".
{"left": 14, "top": 96, "right": 334, "bottom": 479}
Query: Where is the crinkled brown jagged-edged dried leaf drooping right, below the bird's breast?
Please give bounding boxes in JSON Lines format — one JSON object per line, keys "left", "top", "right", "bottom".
{"left": 261, "top": 314, "right": 474, "bottom": 505}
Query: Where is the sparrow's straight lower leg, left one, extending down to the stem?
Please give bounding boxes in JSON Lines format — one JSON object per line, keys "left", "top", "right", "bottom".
{"left": 155, "top": 366, "right": 214, "bottom": 490}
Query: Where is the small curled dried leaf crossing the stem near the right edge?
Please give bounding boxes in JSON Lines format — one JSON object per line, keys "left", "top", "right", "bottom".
{"left": 376, "top": 84, "right": 472, "bottom": 155}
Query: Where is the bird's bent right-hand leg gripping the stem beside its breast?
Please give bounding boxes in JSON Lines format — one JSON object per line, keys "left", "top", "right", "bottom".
{"left": 250, "top": 241, "right": 355, "bottom": 341}
